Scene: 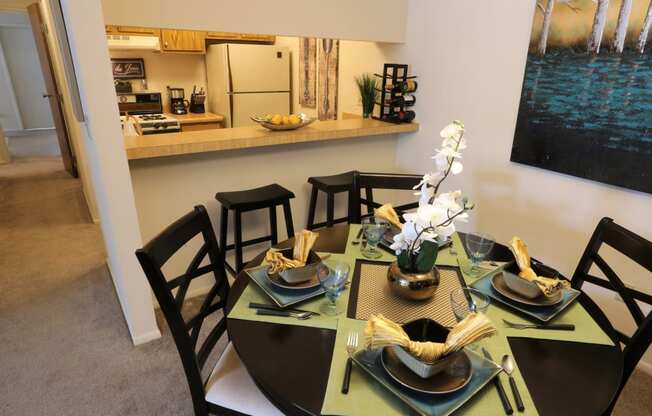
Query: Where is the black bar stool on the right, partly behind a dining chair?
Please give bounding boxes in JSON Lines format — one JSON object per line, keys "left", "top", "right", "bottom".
{"left": 306, "top": 171, "right": 374, "bottom": 230}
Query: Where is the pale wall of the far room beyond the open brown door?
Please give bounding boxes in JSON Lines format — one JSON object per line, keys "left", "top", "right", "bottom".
{"left": 0, "top": 12, "right": 54, "bottom": 129}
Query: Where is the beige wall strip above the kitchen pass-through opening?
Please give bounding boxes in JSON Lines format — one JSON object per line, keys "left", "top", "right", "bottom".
{"left": 102, "top": 0, "right": 407, "bottom": 42}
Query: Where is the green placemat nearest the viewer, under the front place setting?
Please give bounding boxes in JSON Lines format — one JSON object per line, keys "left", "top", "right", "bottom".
{"left": 322, "top": 318, "right": 538, "bottom": 416}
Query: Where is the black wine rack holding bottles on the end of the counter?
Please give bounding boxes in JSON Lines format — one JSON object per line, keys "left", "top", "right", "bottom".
{"left": 374, "top": 64, "right": 417, "bottom": 123}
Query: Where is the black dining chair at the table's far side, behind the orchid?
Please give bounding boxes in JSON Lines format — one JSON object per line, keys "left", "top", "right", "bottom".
{"left": 349, "top": 172, "right": 423, "bottom": 223}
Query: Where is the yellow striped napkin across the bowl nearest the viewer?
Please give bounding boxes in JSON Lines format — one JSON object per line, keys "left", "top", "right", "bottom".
{"left": 364, "top": 313, "right": 496, "bottom": 363}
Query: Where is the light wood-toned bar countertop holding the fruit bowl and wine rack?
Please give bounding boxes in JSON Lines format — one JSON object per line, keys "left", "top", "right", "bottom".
{"left": 124, "top": 119, "right": 419, "bottom": 160}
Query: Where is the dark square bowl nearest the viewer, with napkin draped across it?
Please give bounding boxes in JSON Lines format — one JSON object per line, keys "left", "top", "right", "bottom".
{"left": 390, "top": 318, "right": 464, "bottom": 378}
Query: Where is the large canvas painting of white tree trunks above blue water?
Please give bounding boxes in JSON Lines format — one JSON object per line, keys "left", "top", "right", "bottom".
{"left": 511, "top": 0, "right": 652, "bottom": 193}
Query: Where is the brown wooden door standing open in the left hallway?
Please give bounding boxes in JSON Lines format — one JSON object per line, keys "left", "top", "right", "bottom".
{"left": 27, "top": 3, "right": 78, "bottom": 178}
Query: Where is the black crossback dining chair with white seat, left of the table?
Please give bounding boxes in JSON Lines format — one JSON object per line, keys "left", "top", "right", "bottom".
{"left": 136, "top": 205, "right": 282, "bottom": 416}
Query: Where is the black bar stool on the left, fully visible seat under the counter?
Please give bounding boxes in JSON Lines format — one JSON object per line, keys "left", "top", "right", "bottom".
{"left": 215, "top": 184, "right": 294, "bottom": 276}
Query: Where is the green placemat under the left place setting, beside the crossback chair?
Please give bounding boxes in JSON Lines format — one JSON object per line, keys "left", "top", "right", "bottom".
{"left": 228, "top": 254, "right": 355, "bottom": 329}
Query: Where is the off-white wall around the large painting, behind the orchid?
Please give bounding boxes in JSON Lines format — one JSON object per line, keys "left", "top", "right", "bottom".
{"left": 394, "top": 0, "right": 652, "bottom": 364}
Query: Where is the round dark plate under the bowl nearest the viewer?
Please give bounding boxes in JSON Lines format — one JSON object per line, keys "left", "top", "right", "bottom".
{"left": 380, "top": 348, "right": 473, "bottom": 394}
